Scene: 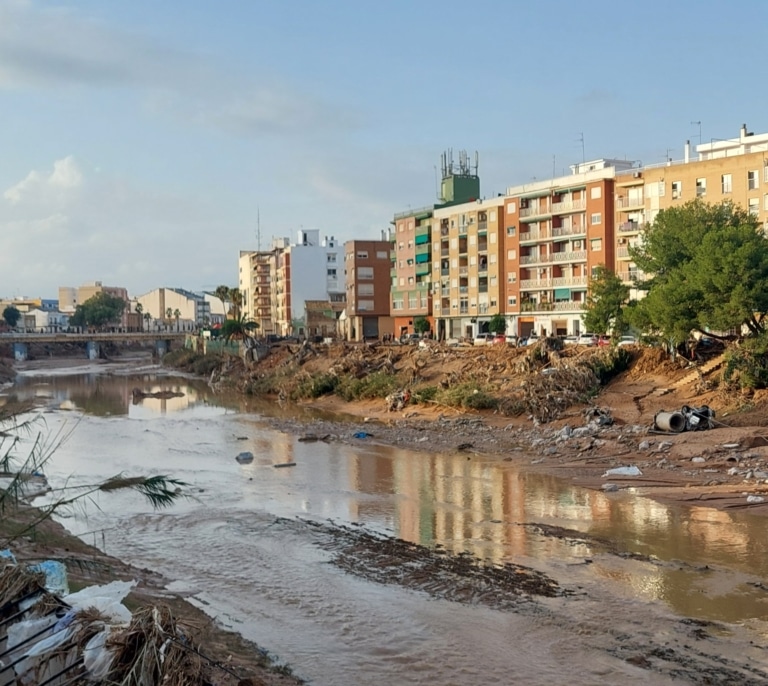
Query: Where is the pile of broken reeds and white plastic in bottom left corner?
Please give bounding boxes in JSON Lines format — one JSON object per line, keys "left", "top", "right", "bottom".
{"left": 0, "top": 551, "right": 206, "bottom": 686}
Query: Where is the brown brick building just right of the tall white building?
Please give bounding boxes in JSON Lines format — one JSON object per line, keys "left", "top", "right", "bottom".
{"left": 344, "top": 239, "right": 395, "bottom": 341}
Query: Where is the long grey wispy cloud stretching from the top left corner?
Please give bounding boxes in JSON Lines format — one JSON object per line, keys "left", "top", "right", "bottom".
{"left": 0, "top": 0, "right": 356, "bottom": 137}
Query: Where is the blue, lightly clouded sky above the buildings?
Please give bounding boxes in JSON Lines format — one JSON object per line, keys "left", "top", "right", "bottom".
{"left": 0, "top": 0, "right": 768, "bottom": 298}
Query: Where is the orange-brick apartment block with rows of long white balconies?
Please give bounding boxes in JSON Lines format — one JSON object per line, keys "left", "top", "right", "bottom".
{"left": 503, "top": 159, "right": 632, "bottom": 336}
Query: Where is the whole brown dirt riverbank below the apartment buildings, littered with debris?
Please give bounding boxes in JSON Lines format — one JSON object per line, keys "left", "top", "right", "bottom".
{"left": 207, "top": 344, "right": 768, "bottom": 514}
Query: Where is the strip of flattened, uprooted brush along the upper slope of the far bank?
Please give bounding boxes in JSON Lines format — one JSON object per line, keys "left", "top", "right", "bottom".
{"left": 176, "top": 339, "right": 631, "bottom": 422}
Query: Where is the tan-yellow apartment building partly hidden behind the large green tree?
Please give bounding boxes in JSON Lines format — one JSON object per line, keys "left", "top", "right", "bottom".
{"left": 615, "top": 125, "right": 768, "bottom": 297}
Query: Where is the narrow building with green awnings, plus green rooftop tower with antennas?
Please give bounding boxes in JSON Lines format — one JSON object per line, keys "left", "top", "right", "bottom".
{"left": 390, "top": 151, "right": 480, "bottom": 336}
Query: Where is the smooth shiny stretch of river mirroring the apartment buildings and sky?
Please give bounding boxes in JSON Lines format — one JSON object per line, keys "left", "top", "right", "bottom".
{"left": 12, "top": 374, "right": 768, "bottom": 621}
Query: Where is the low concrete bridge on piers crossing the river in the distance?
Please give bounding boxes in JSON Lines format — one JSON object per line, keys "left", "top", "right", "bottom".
{"left": 0, "top": 331, "right": 190, "bottom": 362}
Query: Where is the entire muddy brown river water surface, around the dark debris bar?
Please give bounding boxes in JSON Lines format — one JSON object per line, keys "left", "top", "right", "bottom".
{"left": 0, "top": 366, "right": 768, "bottom": 684}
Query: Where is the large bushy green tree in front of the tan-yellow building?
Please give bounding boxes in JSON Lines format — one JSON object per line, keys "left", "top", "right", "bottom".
{"left": 630, "top": 200, "right": 768, "bottom": 344}
